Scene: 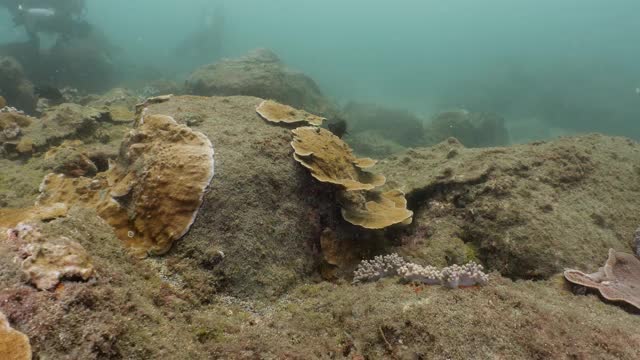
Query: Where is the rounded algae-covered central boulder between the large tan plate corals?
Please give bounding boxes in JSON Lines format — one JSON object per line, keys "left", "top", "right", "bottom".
{"left": 146, "top": 96, "right": 323, "bottom": 295}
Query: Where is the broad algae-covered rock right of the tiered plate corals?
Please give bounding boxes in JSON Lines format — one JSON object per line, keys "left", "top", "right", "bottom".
{"left": 377, "top": 135, "right": 640, "bottom": 278}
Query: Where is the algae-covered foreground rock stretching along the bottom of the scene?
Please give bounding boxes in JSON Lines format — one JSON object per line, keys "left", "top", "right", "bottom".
{"left": 0, "top": 210, "right": 640, "bottom": 360}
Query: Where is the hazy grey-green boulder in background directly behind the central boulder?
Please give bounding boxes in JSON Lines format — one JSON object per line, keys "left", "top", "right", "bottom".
{"left": 186, "top": 49, "right": 333, "bottom": 116}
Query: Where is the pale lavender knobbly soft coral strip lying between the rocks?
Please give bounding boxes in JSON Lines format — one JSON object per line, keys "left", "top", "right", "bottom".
{"left": 353, "top": 253, "right": 489, "bottom": 289}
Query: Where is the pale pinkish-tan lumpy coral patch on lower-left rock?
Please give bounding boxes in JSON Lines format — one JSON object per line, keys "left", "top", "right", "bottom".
{"left": 8, "top": 225, "right": 94, "bottom": 290}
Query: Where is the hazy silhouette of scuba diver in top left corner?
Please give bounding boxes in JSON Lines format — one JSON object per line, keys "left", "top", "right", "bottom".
{"left": 0, "top": 0, "right": 116, "bottom": 93}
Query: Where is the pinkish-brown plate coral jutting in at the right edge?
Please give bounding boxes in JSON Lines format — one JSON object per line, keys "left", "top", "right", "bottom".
{"left": 564, "top": 249, "right": 640, "bottom": 309}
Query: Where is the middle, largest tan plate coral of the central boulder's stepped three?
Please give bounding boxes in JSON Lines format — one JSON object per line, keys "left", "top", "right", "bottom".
{"left": 291, "top": 126, "right": 385, "bottom": 190}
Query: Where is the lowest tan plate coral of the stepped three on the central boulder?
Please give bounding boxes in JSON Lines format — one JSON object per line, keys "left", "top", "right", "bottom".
{"left": 339, "top": 190, "right": 413, "bottom": 229}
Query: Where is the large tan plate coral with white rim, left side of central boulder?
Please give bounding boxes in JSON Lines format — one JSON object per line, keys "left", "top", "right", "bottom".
{"left": 38, "top": 115, "right": 214, "bottom": 255}
